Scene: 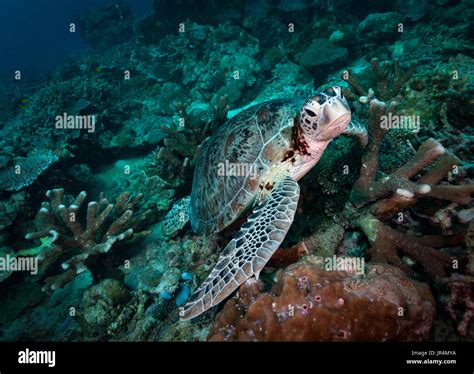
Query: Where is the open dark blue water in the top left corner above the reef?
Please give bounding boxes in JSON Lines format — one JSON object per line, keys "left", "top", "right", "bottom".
{"left": 0, "top": 0, "right": 151, "bottom": 80}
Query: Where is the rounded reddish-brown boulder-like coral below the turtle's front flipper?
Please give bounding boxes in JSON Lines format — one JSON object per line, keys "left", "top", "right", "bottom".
{"left": 208, "top": 263, "right": 435, "bottom": 341}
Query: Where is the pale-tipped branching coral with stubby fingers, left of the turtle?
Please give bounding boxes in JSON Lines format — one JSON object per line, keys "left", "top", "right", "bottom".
{"left": 24, "top": 189, "right": 148, "bottom": 291}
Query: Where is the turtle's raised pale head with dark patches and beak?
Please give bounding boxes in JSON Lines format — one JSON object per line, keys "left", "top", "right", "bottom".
{"left": 299, "top": 86, "right": 351, "bottom": 141}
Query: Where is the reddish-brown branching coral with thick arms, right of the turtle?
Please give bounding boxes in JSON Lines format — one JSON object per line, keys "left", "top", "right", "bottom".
{"left": 343, "top": 99, "right": 474, "bottom": 277}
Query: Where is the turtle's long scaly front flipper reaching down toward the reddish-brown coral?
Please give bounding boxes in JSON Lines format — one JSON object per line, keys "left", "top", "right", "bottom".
{"left": 180, "top": 175, "right": 300, "bottom": 320}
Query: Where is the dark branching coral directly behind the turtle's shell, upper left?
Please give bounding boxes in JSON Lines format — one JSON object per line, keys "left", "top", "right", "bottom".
{"left": 149, "top": 96, "right": 229, "bottom": 186}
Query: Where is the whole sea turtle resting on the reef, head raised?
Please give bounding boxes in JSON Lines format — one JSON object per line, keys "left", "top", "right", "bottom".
{"left": 162, "top": 87, "right": 366, "bottom": 320}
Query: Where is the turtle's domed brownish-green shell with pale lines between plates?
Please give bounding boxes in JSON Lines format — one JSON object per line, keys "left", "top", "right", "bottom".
{"left": 190, "top": 100, "right": 301, "bottom": 233}
